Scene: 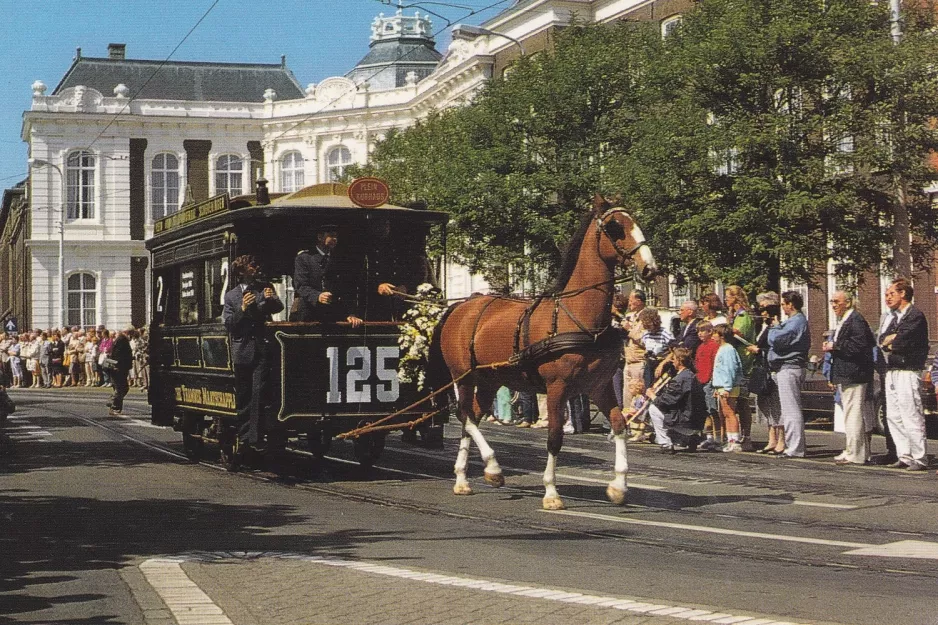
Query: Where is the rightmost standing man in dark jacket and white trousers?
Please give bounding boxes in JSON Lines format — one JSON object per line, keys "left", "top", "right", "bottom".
{"left": 879, "top": 278, "right": 928, "bottom": 471}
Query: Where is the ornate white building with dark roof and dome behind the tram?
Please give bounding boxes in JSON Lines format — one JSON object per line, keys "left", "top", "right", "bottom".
{"left": 22, "top": 0, "right": 688, "bottom": 328}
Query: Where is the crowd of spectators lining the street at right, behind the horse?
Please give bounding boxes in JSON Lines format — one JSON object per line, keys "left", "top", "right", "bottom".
{"left": 488, "top": 278, "right": 938, "bottom": 471}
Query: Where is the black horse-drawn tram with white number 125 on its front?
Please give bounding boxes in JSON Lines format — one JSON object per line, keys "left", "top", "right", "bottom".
{"left": 147, "top": 181, "right": 446, "bottom": 469}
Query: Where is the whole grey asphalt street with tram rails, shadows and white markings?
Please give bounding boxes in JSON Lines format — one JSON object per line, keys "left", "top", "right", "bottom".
{"left": 0, "top": 391, "right": 938, "bottom": 625}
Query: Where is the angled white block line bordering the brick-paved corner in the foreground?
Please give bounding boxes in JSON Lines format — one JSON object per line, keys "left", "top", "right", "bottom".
{"left": 146, "top": 551, "right": 797, "bottom": 625}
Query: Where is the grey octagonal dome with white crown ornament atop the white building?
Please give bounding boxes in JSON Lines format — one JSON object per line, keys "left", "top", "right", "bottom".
{"left": 345, "top": 9, "right": 443, "bottom": 91}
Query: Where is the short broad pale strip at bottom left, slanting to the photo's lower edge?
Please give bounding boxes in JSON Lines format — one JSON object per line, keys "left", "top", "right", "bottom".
{"left": 140, "top": 558, "right": 234, "bottom": 625}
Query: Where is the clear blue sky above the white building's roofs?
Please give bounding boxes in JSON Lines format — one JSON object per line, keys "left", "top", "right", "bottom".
{"left": 0, "top": 0, "right": 513, "bottom": 188}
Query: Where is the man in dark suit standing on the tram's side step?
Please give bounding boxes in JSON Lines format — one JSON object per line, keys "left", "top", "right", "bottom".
{"left": 222, "top": 255, "right": 283, "bottom": 446}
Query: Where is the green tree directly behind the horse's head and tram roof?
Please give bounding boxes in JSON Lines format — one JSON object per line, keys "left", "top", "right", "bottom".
{"left": 352, "top": 24, "right": 657, "bottom": 289}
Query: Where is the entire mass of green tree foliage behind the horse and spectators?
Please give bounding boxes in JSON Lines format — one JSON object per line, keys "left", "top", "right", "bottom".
{"left": 355, "top": 0, "right": 938, "bottom": 289}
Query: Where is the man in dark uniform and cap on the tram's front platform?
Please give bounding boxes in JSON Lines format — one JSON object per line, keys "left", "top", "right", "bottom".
{"left": 290, "top": 225, "right": 362, "bottom": 328}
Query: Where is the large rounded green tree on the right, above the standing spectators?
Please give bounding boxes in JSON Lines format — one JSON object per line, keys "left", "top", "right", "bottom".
{"left": 611, "top": 0, "right": 938, "bottom": 288}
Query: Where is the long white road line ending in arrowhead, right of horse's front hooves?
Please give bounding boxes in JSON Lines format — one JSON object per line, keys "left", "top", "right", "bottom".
{"left": 541, "top": 510, "right": 938, "bottom": 560}
